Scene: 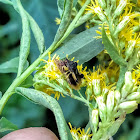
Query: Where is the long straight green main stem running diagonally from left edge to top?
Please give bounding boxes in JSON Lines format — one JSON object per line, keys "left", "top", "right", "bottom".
{"left": 0, "top": 0, "right": 90, "bottom": 114}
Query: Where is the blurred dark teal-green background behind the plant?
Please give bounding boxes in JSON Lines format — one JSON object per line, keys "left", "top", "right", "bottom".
{"left": 0, "top": 0, "right": 140, "bottom": 140}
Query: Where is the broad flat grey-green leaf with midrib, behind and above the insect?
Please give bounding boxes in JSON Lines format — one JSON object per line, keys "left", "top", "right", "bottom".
{"left": 53, "top": 26, "right": 104, "bottom": 64}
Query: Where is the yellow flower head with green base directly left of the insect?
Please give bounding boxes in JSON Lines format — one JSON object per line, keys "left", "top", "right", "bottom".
{"left": 34, "top": 52, "right": 67, "bottom": 100}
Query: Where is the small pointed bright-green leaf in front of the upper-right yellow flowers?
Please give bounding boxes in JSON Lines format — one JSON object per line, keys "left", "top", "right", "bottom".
{"left": 102, "top": 26, "right": 127, "bottom": 66}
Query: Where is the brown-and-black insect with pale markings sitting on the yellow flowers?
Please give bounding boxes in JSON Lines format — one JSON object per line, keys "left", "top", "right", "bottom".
{"left": 54, "top": 59, "right": 84, "bottom": 90}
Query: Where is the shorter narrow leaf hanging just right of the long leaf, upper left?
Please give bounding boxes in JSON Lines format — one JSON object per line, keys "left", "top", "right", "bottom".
{"left": 26, "top": 12, "right": 45, "bottom": 54}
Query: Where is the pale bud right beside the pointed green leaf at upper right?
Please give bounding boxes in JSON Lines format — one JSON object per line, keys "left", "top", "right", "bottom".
{"left": 125, "top": 40, "right": 136, "bottom": 60}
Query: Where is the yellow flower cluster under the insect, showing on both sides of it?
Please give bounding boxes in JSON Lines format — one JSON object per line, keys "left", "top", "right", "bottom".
{"left": 34, "top": 53, "right": 119, "bottom": 99}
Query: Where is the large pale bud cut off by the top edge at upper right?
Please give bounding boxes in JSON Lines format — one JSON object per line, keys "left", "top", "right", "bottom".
{"left": 113, "top": 0, "right": 127, "bottom": 18}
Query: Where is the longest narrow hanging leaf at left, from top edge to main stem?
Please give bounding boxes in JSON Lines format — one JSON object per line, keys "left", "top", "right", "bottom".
{"left": 17, "top": 0, "right": 31, "bottom": 76}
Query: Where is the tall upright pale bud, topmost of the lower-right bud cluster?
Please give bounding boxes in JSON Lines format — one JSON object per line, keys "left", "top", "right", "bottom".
{"left": 121, "top": 71, "right": 134, "bottom": 98}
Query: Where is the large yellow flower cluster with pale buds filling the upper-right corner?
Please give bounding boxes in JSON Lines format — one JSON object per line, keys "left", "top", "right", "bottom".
{"left": 86, "top": 0, "right": 140, "bottom": 61}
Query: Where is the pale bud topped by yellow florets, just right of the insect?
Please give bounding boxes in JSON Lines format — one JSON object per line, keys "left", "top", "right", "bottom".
{"left": 92, "top": 79, "right": 101, "bottom": 96}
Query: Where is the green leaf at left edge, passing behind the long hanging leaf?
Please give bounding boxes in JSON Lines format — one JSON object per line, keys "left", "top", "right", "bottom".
{"left": 0, "top": 57, "right": 29, "bottom": 73}
